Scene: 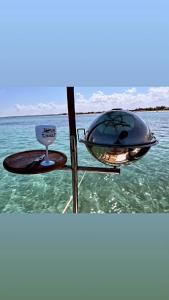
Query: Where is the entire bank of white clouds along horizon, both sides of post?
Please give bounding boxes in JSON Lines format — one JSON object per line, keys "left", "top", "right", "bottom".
{"left": 4, "top": 87, "right": 169, "bottom": 115}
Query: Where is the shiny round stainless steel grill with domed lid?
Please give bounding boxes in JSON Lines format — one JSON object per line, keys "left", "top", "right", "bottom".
{"left": 80, "top": 109, "right": 157, "bottom": 165}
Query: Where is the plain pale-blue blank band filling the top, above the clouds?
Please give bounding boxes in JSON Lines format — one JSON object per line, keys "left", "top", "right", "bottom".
{"left": 0, "top": 0, "right": 169, "bottom": 86}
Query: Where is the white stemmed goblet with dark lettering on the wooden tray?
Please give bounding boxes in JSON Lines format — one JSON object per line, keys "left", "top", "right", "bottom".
{"left": 35, "top": 125, "right": 56, "bottom": 167}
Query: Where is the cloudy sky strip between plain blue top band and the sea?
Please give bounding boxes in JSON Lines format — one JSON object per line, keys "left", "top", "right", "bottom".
{"left": 0, "top": 86, "right": 169, "bottom": 117}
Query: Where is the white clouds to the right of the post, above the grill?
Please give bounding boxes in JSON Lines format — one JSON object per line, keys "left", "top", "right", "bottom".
{"left": 76, "top": 87, "right": 169, "bottom": 111}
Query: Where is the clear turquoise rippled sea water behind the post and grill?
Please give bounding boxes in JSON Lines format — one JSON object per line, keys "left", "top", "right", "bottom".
{"left": 0, "top": 112, "right": 169, "bottom": 213}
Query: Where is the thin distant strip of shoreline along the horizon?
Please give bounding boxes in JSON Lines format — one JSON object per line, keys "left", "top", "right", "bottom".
{"left": 0, "top": 107, "right": 169, "bottom": 118}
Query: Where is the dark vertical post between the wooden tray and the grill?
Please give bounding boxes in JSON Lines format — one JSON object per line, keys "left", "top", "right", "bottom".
{"left": 67, "top": 87, "right": 78, "bottom": 214}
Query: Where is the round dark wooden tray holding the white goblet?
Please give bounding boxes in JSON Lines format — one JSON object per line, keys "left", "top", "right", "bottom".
{"left": 3, "top": 150, "right": 67, "bottom": 175}
